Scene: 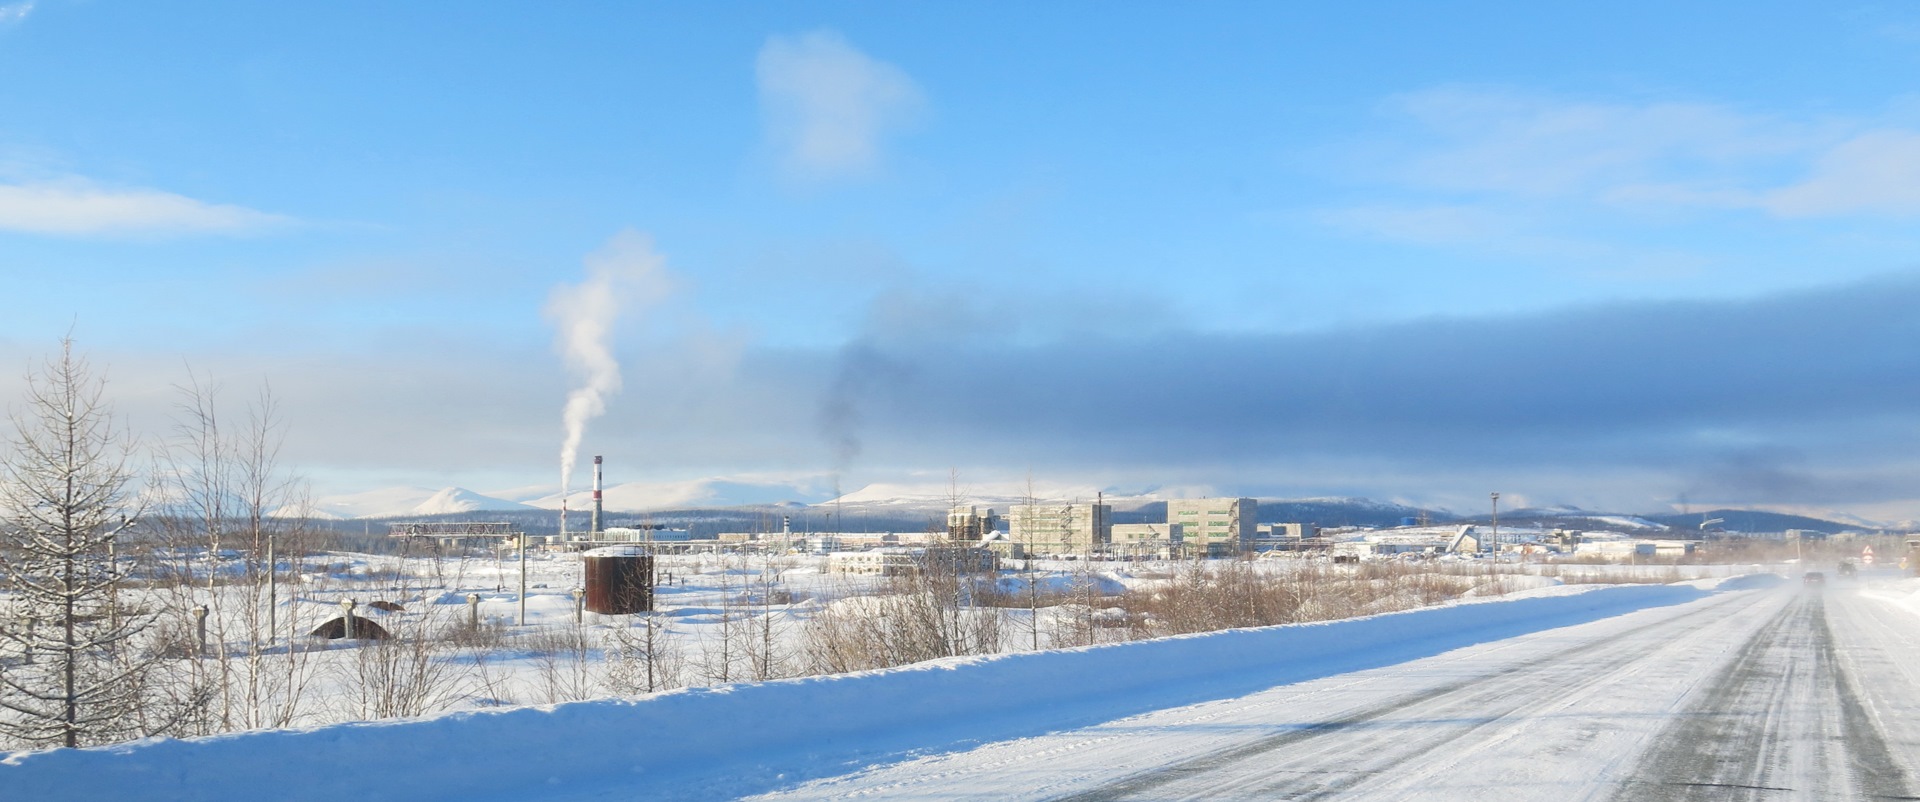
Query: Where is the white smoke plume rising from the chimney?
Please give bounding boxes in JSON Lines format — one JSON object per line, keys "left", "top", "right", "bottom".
{"left": 545, "top": 228, "right": 674, "bottom": 493}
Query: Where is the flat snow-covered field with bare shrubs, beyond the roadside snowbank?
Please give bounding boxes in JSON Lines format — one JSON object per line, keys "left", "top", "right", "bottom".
{"left": 82, "top": 551, "right": 1755, "bottom": 731}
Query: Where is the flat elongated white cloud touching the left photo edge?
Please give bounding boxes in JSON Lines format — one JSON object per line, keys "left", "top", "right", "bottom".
{"left": 0, "top": 178, "right": 288, "bottom": 236}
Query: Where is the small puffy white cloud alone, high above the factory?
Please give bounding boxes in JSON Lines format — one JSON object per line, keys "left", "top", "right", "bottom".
{"left": 755, "top": 31, "right": 924, "bottom": 178}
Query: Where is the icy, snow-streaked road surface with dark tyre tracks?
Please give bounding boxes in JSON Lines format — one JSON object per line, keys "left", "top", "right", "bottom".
{"left": 758, "top": 583, "right": 1920, "bottom": 802}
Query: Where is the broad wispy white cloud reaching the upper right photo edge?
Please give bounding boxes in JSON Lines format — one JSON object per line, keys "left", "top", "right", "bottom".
{"left": 1321, "top": 88, "right": 1920, "bottom": 232}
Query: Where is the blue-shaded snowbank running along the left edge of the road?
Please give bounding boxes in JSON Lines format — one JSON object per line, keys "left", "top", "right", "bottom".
{"left": 0, "top": 585, "right": 1713, "bottom": 800}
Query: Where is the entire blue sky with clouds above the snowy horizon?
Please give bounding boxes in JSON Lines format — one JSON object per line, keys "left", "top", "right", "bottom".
{"left": 0, "top": 0, "right": 1920, "bottom": 518}
